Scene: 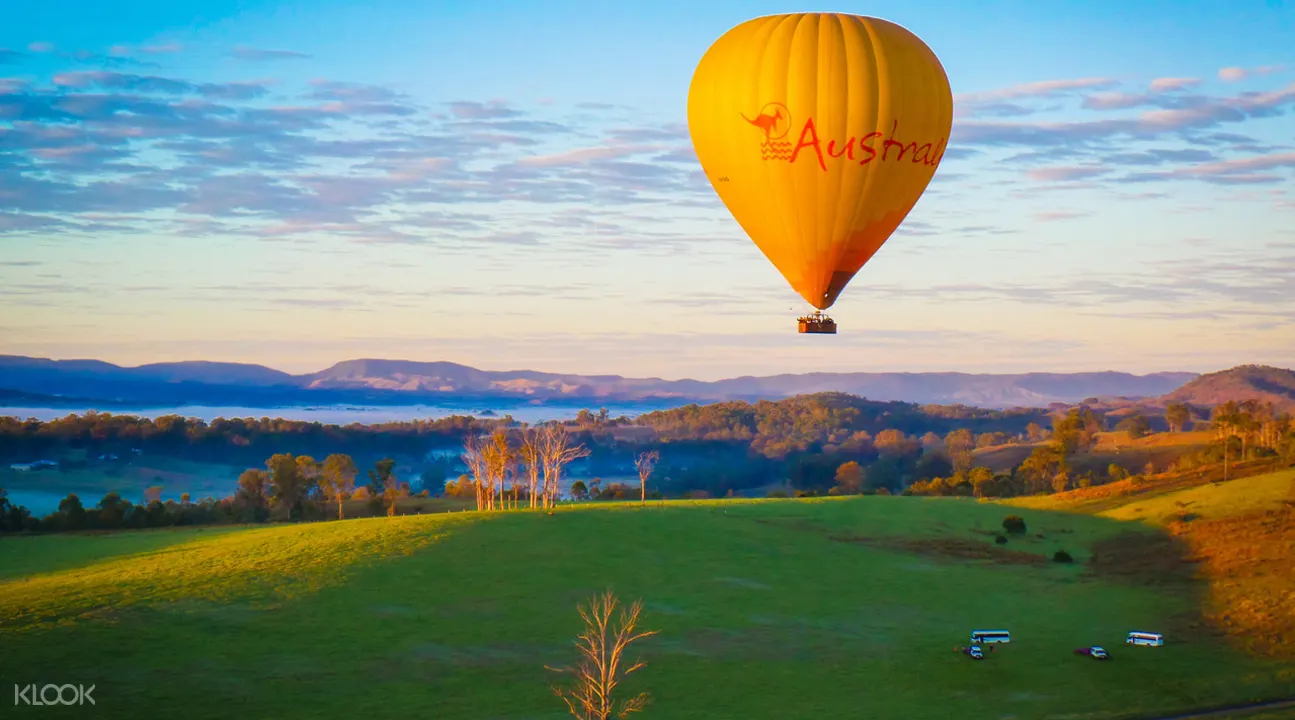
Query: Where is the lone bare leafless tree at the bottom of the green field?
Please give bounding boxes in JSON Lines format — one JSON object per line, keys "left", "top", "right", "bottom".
{"left": 545, "top": 591, "right": 658, "bottom": 720}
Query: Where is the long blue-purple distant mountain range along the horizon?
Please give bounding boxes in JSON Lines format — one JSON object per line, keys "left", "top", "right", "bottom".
{"left": 0, "top": 355, "right": 1222, "bottom": 409}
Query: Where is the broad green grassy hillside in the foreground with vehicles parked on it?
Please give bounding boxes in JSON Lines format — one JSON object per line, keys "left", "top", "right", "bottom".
{"left": 0, "top": 497, "right": 1295, "bottom": 720}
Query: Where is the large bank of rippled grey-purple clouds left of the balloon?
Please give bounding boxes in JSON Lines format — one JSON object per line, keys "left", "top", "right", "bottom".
{"left": 0, "top": 70, "right": 710, "bottom": 246}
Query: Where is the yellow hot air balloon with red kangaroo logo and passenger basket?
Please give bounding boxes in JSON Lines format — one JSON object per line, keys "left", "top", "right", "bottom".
{"left": 688, "top": 13, "right": 953, "bottom": 333}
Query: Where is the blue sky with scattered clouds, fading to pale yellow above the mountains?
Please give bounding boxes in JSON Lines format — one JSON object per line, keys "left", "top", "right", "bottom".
{"left": 0, "top": 0, "right": 1295, "bottom": 378}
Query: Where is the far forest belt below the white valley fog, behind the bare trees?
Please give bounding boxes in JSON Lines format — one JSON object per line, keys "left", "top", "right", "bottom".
{"left": 0, "top": 392, "right": 1046, "bottom": 462}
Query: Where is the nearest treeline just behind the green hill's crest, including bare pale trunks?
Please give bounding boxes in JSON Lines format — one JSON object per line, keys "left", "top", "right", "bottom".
{"left": 0, "top": 398, "right": 1295, "bottom": 531}
